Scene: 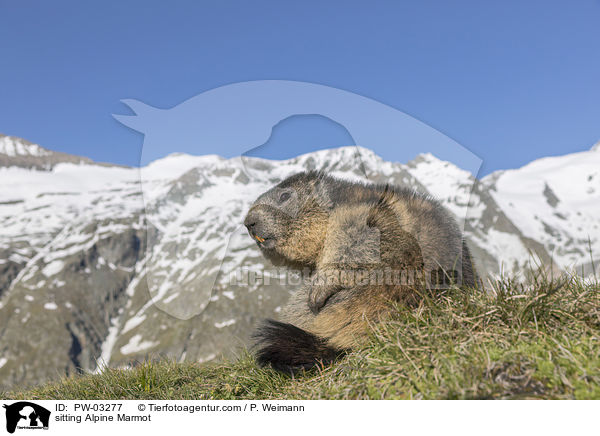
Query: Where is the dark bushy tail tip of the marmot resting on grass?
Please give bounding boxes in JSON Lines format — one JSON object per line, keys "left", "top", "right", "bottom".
{"left": 253, "top": 319, "right": 343, "bottom": 374}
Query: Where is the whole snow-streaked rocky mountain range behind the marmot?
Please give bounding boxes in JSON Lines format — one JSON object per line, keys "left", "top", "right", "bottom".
{"left": 0, "top": 136, "right": 600, "bottom": 389}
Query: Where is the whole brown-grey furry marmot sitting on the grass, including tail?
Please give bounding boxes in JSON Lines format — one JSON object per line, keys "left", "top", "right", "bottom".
{"left": 244, "top": 171, "right": 476, "bottom": 373}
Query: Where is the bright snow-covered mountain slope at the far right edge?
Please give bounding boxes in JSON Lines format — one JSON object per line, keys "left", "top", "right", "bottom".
{"left": 482, "top": 146, "right": 600, "bottom": 273}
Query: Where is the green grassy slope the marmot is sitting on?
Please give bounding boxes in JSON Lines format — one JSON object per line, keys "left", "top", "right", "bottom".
{"left": 2, "top": 277, "right": 600, "bottom": 399}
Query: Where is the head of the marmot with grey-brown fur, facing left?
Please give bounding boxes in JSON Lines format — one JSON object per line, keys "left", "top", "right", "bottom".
{"left": 244, "top": 171, "right": 333, "bottom": 266}
